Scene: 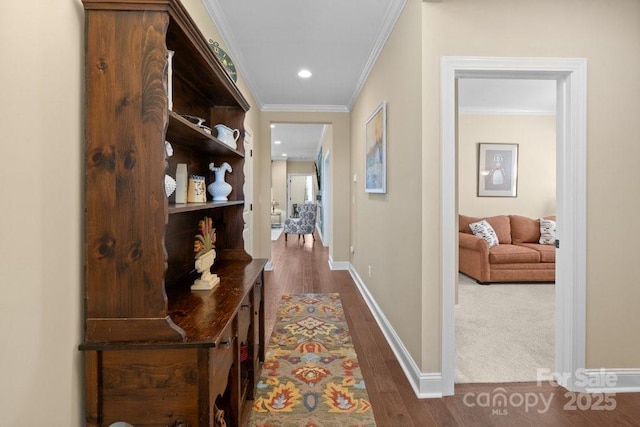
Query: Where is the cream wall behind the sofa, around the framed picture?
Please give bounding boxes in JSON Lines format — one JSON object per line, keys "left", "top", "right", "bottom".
{"left": 458, "top": 114, "right": 556, "bottom": 218}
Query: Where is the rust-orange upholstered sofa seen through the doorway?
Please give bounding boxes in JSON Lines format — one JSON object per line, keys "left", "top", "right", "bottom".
{"left": 458, "top": 215, "right": 556, "bottom": 284}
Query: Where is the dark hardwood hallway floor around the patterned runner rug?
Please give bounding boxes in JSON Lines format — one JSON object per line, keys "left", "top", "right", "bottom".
{"left": 258, "top": 235, "right": 640, "bottom": 427}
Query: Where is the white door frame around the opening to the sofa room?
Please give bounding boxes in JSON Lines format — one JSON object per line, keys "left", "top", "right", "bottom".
{"left": 440, "top": 57, "right": 587, "bottom": 396}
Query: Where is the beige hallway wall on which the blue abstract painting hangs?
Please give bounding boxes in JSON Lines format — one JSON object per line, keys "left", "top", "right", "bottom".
{"left": 350, "top": 1, "right": 424, "bottom": 363}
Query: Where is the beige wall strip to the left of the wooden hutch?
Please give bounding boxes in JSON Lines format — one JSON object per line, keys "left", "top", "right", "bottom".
{"left": 0, "top": 0, "right": 84, "bottom": 426}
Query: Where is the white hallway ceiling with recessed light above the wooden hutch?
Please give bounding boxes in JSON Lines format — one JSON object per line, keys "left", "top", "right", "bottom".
{"left": 203, "top": 0, "right": 406, "bottom": 111}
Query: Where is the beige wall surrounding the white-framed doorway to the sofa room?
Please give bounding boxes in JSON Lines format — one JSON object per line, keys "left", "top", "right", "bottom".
{"left": 424, "top": 0, "right": 640, "bottom": 370}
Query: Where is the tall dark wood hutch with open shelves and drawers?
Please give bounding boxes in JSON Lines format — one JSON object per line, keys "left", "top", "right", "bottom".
{"left": 80, "top": 0, "right": 266, "bottom": 426}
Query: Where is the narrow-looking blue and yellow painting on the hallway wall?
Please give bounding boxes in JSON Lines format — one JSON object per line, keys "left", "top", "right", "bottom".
{"left": 364, "top": 102, "right": 387, "bottom": 193}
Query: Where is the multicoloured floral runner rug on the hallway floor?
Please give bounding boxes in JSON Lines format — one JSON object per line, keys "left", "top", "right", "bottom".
{"left": 249, "top": 293, "right": 376, "bottom": 427}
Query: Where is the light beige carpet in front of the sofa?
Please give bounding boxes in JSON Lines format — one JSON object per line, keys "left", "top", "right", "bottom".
{"left": 455, "top": 274, "right": 555, "bottom": 383}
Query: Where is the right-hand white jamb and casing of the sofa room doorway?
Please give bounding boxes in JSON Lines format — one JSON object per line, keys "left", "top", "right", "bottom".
{"left": 556, "top": 60, "right": 587, "bottom": 390}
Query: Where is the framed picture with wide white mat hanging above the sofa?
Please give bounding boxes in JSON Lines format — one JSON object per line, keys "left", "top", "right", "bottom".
{"left": 478, "top": 142, "right": 518, "bottom": 197}
